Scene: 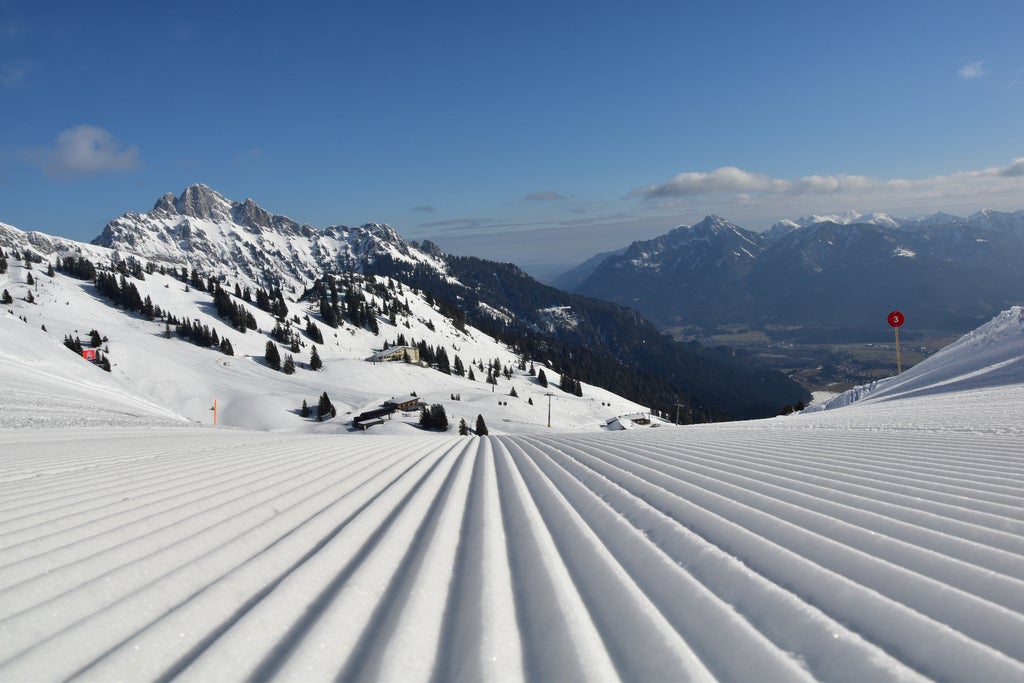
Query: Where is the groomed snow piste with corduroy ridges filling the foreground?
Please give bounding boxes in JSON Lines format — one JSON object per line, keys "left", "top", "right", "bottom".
{"left": 0, "top": 309, "right": 1024, "bottom": 681}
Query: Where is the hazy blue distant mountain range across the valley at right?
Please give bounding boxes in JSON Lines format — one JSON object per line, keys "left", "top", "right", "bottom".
{"left": 554, "top": 211, "right": 1024, "bottom": 339}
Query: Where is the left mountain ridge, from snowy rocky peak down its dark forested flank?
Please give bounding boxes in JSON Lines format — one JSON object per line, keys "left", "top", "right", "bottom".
{"left": 0, "top": 184, "right": 809, "bottom": 421}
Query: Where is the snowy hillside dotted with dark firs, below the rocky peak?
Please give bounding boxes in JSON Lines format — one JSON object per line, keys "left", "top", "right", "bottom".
{"left": 0, "top": 226, "right": 647, "bottom": 434}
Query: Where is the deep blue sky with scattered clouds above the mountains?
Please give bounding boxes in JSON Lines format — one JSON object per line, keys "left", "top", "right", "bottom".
{"left": 0, "top": 0, "right": 1024, "bottom": 271}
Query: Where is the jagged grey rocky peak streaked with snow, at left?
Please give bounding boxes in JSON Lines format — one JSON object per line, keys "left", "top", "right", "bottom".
{"left": 92, "top": 184, "right": 443, "bottom": 291}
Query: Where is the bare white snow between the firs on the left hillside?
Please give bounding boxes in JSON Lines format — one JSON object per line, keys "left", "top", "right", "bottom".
{"left": 0, "top": 247, "right": 646, "bottom": 437}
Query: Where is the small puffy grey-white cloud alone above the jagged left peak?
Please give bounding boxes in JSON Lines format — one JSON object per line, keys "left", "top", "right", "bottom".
{"left": 43, "top": 125, "right": 140, "bottom": 178}
